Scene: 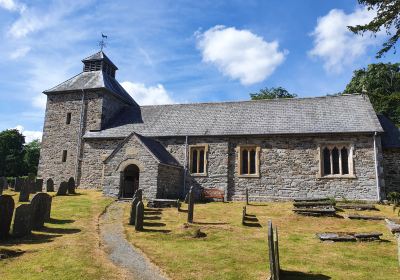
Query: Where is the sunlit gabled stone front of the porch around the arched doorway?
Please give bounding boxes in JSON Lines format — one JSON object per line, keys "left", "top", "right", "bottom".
{"left": 103, "top": 135, "right": 159, "bottom": 198}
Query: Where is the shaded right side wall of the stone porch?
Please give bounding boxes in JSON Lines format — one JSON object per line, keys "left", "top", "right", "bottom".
{"left": 157, "top": 164, "right": 183, "bottom": 199}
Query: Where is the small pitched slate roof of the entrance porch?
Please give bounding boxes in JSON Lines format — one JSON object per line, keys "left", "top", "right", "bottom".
{"left": 104, "top": 132, "right": 180, "bottom": 166}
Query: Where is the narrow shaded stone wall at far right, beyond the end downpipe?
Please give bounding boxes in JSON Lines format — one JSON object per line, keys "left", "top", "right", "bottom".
{"left": 383, "top": 149, "right": 400, "bottom": 194}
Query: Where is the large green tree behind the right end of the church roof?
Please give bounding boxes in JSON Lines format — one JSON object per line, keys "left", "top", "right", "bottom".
{"left": 343, "top": 63, "right": 400, "bottom": 126}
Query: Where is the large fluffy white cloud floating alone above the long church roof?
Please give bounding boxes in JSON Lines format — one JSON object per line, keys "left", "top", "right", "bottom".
{"left": 196, "top": 25, "right": 287, "bottom": 85}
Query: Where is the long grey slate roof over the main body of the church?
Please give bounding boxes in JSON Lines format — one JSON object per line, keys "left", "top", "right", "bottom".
{"left": 84, "top": 95, "right": 383, "bottom": 138}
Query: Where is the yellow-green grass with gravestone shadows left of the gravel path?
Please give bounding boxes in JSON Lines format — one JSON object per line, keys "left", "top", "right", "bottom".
{"left": 0, "top": 190, "right": 122, "bottom": 280}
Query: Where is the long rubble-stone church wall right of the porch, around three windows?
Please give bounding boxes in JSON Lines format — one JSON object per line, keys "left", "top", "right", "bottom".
{"left": 159, "top": 135, "right": 379, "bottom": 200}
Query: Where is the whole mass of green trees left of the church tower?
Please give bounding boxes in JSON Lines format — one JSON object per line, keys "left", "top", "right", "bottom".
{"left": 0, "top": 129, "right": 40, "bottom": 177}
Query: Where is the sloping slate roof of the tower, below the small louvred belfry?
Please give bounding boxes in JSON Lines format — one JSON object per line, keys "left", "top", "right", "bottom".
{"left": 43, "top": 70, "right": 137, "bottom": 105}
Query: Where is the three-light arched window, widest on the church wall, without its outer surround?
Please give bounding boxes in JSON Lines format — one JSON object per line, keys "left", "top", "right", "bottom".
{"left": 320, "top": 145, "right": 353, "bottom": 177}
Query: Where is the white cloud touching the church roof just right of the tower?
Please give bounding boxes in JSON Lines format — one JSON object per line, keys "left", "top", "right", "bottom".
{"left": 121, "top": 81, "right": 175, "bottom": 105}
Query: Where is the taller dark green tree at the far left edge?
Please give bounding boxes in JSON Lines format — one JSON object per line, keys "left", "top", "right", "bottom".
{"left": 0, "top": 129, "right": 25, "bottom": 176}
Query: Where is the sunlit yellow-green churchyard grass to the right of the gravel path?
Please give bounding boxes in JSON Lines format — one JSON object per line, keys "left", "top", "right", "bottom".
{"left": 124, "top": 202, "right": 400, "bottom": 280}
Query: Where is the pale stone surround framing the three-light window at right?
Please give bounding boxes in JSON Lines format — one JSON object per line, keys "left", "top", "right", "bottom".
{"left": 317, "top": 141, "right": 357, "bottom": 179}
